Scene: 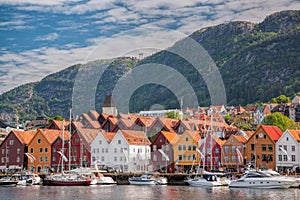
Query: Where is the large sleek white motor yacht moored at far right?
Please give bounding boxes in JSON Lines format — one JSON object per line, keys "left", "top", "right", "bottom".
{"left": 229, "top": 171, "right": 296, "bottom": 189}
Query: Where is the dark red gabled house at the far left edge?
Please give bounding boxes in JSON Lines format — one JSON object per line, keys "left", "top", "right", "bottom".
{"left": 0, "top": 130, "right": 36, "bottom": 172}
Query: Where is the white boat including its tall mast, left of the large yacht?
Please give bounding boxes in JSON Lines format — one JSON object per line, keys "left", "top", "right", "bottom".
{"left": 186, "top": 111, "right": 230, "bottom": 187}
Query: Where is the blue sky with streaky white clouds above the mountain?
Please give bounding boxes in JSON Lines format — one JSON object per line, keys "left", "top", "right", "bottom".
{"left": 0, "top": 0, "right": 300, "bottom": 94}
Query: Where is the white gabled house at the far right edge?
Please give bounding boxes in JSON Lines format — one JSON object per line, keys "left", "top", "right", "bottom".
{"left": 276, "top": 129, "right": 300, "bottom": 172}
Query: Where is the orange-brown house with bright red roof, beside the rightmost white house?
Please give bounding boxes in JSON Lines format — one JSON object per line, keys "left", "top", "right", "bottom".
{"left": 245, "top": 125, "right": 282, "bottom": 170}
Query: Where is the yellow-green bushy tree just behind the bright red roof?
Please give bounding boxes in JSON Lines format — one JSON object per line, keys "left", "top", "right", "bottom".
{"left": 262, "top": 112, "right": 299, "bottom": 131}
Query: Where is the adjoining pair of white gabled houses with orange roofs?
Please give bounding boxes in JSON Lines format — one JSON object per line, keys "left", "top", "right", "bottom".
{"left": 91, "top": 130, "right": 151, "bottom": 172}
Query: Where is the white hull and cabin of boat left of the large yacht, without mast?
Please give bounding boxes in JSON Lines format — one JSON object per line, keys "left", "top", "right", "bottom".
{"left": 186, "top": 172, "right": 230, "bottom": 187}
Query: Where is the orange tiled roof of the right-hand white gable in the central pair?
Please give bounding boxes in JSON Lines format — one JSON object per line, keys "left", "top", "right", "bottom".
{"left": 120, "top": 130, "right": 151, "bottom": 145}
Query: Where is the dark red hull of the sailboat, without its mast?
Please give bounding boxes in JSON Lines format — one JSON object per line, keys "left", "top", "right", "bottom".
{"left": 43, "top": 173, "right": 92, "bottom": 186}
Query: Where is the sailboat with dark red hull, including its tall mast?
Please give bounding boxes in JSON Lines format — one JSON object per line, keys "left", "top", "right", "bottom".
{"left": 43, "top": 121, "right": 92, "bottom": 186}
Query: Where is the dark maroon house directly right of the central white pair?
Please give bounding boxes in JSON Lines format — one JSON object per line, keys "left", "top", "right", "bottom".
{"left": 150, "top": 131, "right": 179, "bottom": 173}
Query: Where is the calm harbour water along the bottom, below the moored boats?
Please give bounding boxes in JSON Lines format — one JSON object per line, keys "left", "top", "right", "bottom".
{"left": 0, "top": 185, "right": 300, "bottom": 200}
